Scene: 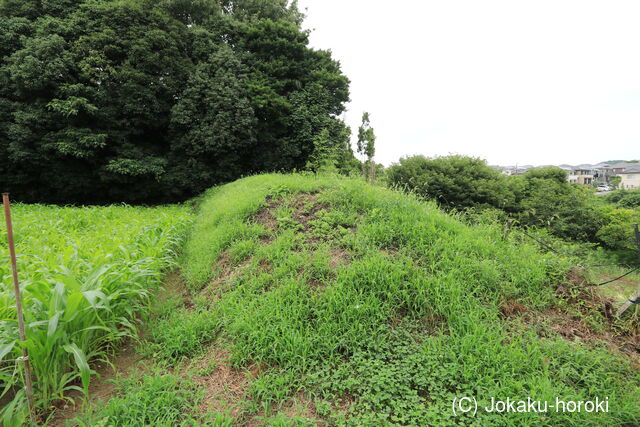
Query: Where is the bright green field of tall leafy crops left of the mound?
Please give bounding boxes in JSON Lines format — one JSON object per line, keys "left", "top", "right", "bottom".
{"left": 0, "top": 204, "right": 191, "bottom": 425}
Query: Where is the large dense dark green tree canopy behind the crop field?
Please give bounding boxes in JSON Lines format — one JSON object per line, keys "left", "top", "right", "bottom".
{"left": 0, "top": 0, "right": 352, "bottom": 203}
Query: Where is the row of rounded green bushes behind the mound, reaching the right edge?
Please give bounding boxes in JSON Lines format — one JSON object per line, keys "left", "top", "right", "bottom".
{"left": 386, "top": 155, "right": 640, "bottom": 261}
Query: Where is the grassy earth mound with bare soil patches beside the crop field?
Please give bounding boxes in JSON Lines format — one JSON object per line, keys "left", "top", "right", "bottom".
{"left": 159, "top": 174, "right": 640, "bottom": 425}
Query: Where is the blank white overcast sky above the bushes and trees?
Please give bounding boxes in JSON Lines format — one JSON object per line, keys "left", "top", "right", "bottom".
{"left": 299, "top": 0, "right": 640, "bottom": 165}
